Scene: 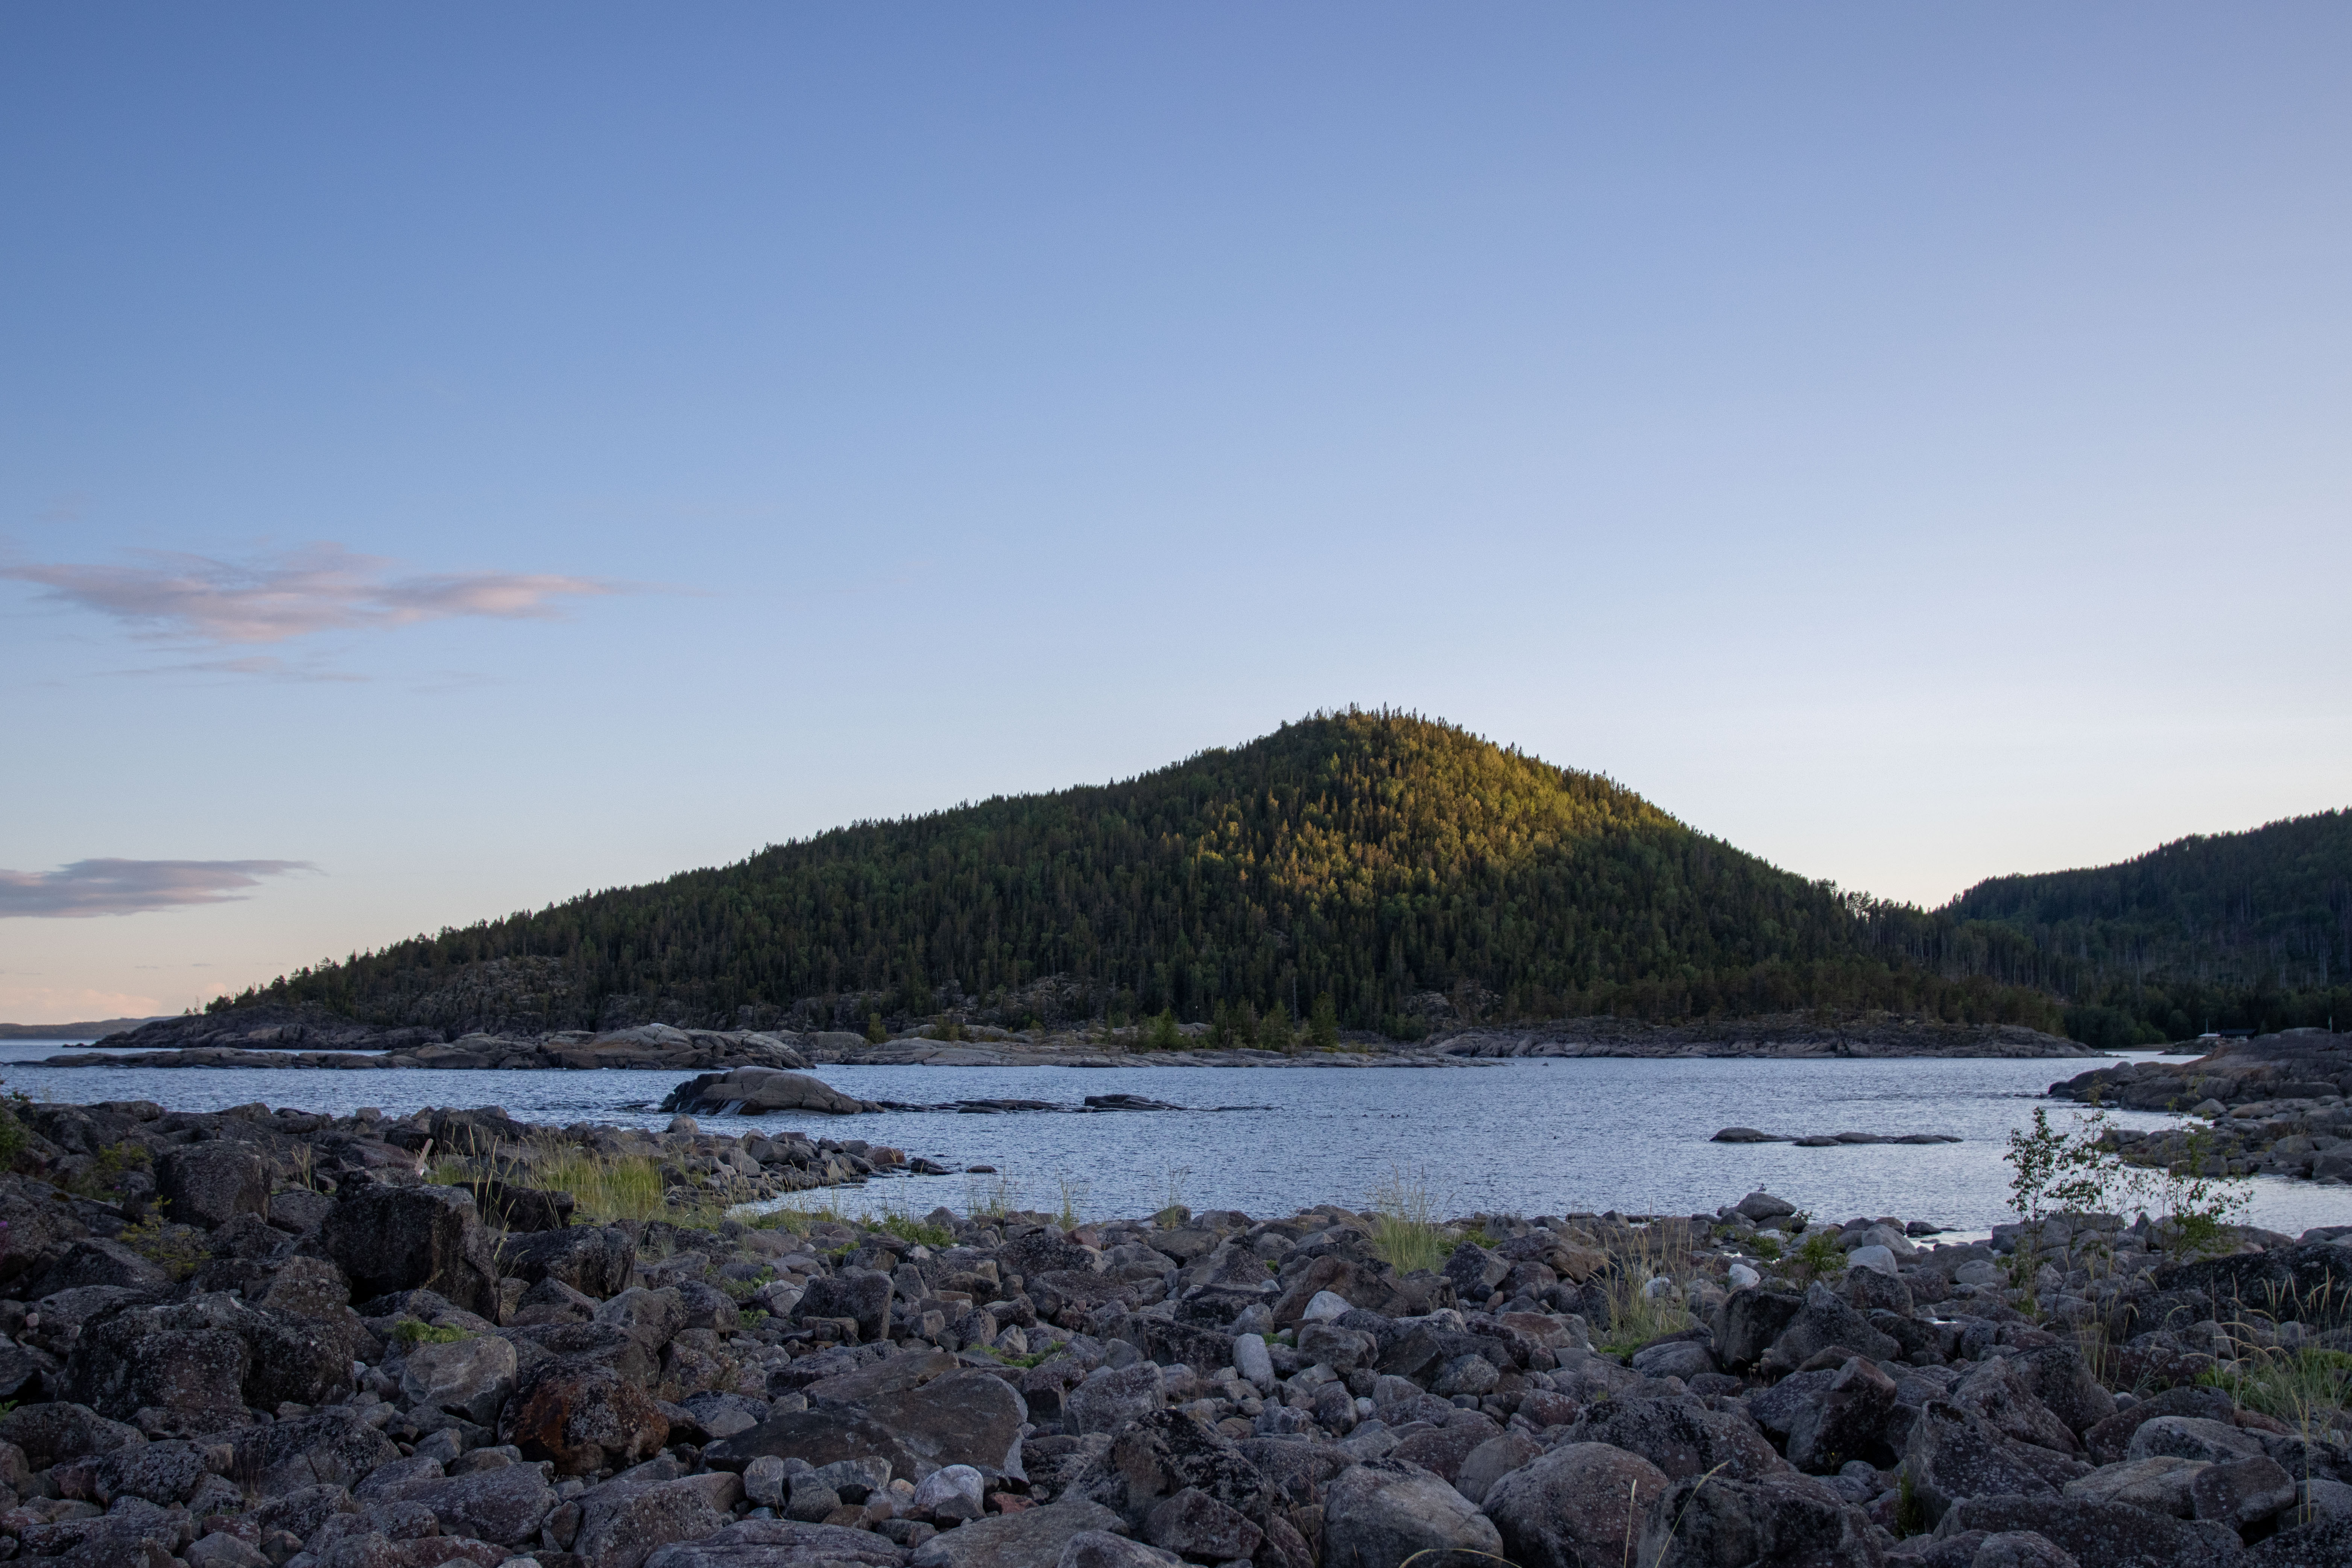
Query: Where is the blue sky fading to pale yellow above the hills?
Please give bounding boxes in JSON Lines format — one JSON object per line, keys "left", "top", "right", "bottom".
{"left": 0, "top": 5, "right": 2352, "bottom": 1020}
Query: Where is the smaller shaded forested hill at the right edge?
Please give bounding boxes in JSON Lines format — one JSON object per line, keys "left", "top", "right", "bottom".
{"left": 1933, "top": 811, "right": 2352, "bottom": 1046}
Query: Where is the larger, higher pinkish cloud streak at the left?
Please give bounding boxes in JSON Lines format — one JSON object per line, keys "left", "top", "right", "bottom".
{"left": 0, "top": 543, "right": 631, "bottom": 644}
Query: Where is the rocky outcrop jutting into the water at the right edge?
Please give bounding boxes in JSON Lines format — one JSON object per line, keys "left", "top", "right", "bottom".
{"left": 2051, "top": 1030, "right": 2352, "bottom": 1185}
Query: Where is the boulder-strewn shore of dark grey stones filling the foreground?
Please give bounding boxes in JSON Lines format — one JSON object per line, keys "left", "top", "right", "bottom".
{"left": 0, "top": 1103, "right": 2352, "bottom": 1568}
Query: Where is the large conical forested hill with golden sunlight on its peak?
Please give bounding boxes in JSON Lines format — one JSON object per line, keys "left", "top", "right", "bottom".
{"left": 207, "top": 712, "right": 2058, "bottom": 1035}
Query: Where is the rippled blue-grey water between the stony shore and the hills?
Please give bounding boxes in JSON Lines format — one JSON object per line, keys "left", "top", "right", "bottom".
{"left": 0, "top": 1041, "right": 2352, "bottom": 1234}
